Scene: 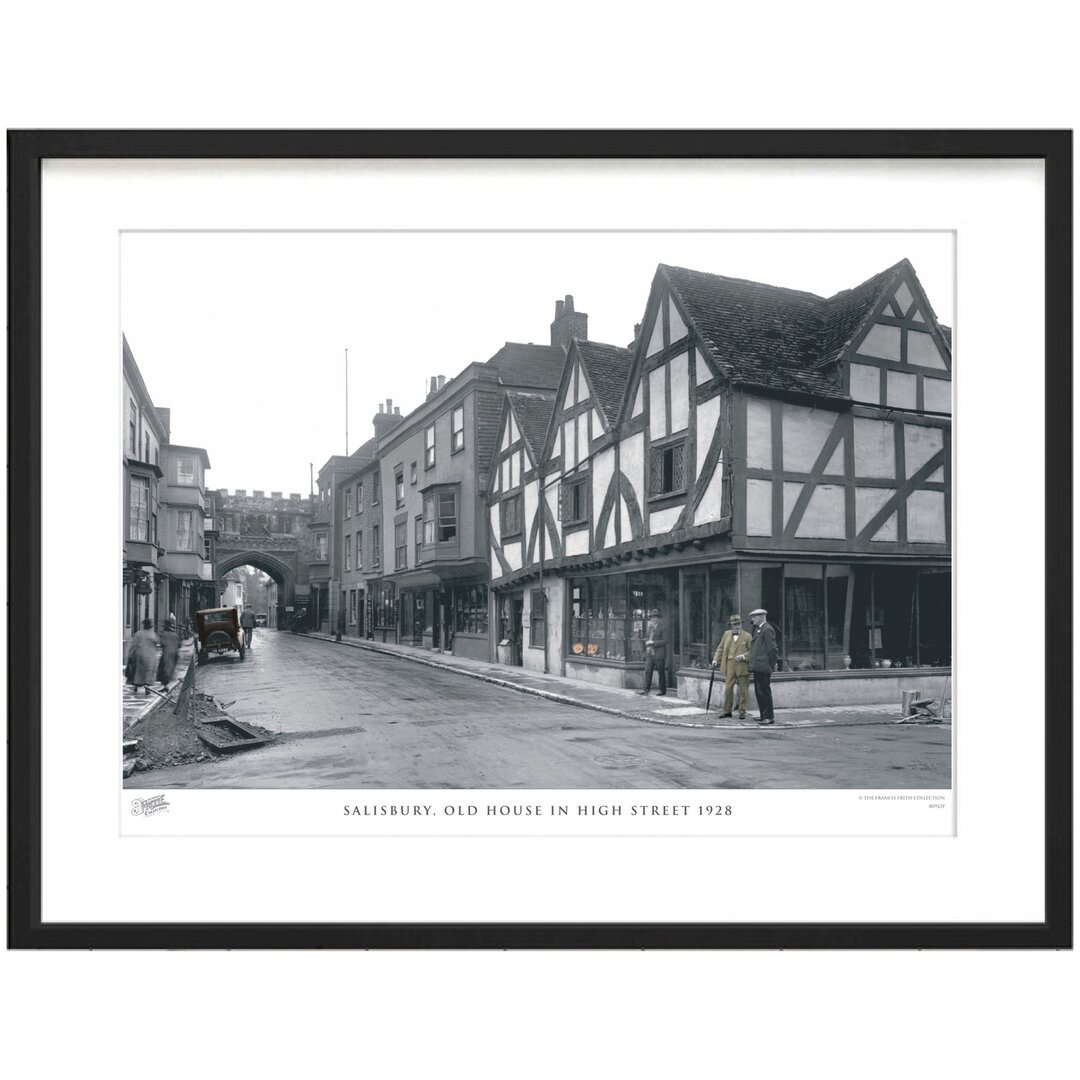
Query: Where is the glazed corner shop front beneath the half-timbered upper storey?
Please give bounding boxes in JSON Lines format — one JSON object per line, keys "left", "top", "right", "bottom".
{"left": 564, "top": 555, "right": 951, "bottom": 707}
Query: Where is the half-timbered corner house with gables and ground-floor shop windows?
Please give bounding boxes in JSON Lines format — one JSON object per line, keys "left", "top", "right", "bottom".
{"left": 488, "top": 260, "right": 953, "bottom": 704}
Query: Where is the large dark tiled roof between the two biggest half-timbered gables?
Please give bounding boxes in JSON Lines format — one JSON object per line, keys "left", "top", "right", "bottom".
{"left": 660, "top": 259, "right": 907, "bottom": 397}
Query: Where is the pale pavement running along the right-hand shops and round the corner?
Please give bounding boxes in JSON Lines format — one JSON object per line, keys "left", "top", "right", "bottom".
{"left": 305, "top": 633, "right": 951, "bottom": 731}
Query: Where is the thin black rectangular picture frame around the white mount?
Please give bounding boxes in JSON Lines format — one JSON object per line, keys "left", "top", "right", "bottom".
{"left": 8, "top": 131, "right": 1072, "bottom": 949}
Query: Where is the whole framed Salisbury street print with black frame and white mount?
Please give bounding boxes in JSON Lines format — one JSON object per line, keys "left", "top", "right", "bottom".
{"left": 9, "top": 131, "right": 1072, "bottom": 948}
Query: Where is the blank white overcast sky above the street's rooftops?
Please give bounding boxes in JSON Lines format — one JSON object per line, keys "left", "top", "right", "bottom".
{"left": 121, "top": 232, "right": 954, "bottom": 495}
